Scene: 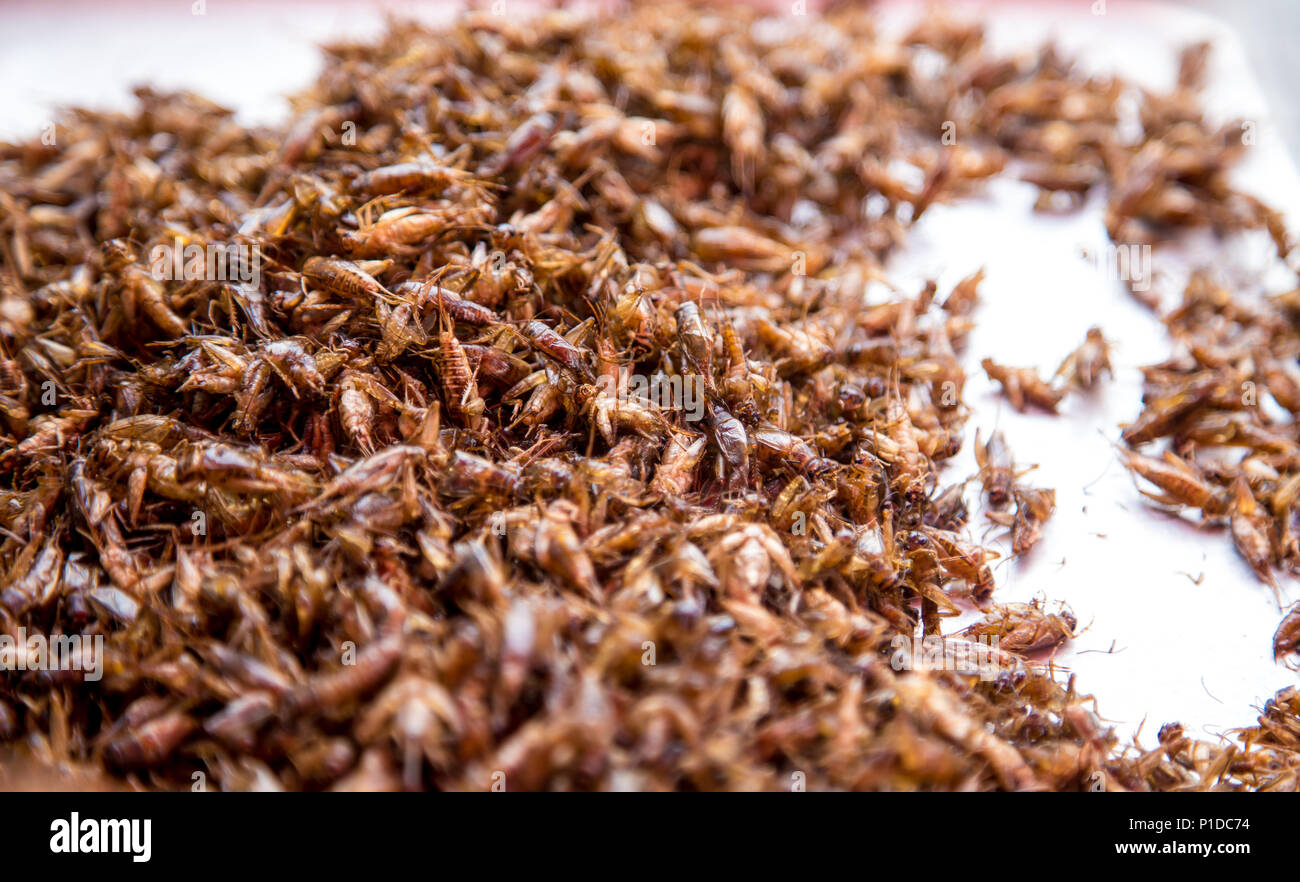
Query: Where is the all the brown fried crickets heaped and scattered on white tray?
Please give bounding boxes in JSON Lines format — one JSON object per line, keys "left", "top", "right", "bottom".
{"left": 0, "top": 3, "right": 1300, "bottom": 790}
